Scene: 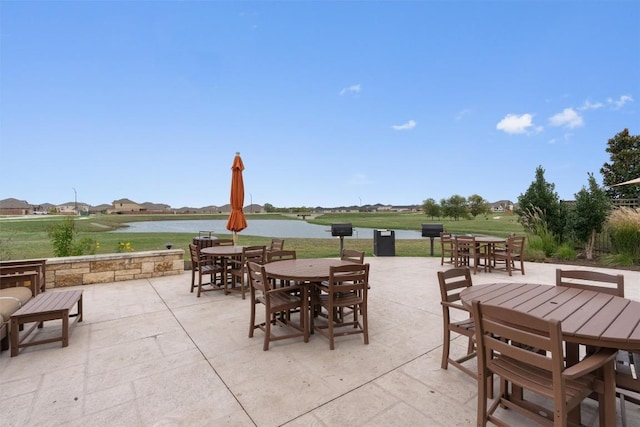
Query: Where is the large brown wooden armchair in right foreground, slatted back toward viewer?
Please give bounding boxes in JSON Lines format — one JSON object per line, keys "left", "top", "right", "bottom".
{"left": 472, "top": 300, "right": 616, "bottom": 426}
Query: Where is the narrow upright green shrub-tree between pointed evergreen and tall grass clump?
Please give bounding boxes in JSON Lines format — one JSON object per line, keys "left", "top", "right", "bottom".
{"left": 570, "top": 173, "right": 611, "bottom": 259}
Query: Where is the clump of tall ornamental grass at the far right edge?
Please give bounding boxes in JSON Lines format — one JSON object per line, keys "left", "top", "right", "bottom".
{"left": 607, "top": 207, "right": 640, "bottom": 265}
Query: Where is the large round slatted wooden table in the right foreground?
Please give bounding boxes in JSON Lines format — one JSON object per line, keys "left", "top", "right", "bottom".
{"left": 460, "top": 283, "right": 640, "bottom": 425}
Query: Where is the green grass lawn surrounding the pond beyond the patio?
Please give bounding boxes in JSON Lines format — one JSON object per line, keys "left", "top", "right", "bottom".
{"left": 0, "top": 212, "right": 523, "bottom": 260}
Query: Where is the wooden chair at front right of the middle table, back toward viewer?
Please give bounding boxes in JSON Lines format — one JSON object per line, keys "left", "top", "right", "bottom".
{"left": 313, "top": 263, "right": 369, "bottom": 350}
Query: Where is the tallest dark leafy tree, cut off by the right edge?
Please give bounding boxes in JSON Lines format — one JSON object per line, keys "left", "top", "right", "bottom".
{"left": 600, "top": 129, "right": 640, "bottom": 199}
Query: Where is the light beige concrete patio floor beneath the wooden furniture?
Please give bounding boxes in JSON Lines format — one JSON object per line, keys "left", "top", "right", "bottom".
{"left": 0, "top": 257, "right": 640, "bottom": 427}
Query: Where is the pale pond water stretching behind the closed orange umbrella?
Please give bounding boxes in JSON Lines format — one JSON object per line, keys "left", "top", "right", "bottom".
{"left": 112, "top": 219, "right": 422, "bottom": 239}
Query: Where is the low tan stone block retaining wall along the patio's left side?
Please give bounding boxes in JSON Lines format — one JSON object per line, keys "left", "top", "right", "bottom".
{"left": 45, "top": 249, "right": 185, "bottom": 289}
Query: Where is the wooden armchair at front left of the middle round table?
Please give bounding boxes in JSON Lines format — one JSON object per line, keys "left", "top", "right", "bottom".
{"left": 247, "top": 261, "right": 309, "bottom": 351}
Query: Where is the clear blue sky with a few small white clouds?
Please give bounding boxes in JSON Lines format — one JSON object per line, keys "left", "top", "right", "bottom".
{"left": 0, "top": 1, "right": 640, "bottom": 208}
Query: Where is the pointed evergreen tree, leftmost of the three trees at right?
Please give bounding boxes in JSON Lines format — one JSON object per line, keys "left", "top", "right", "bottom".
{"left": 517, "top": 166, "right": 567, "bottom": 241}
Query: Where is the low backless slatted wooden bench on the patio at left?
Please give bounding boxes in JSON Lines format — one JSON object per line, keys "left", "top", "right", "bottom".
{"left": 10, "top": 290, "right": 82, "bottom": 357}
